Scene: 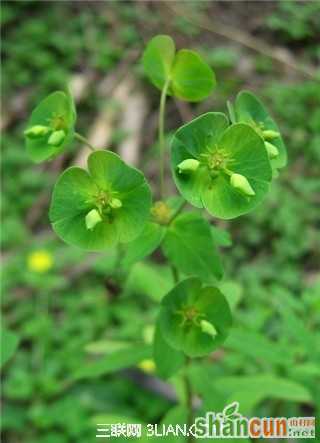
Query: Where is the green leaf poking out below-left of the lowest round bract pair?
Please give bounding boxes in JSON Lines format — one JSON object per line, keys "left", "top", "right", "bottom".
{"left": 153, "top": 322, "right": 185, "bottom": 379}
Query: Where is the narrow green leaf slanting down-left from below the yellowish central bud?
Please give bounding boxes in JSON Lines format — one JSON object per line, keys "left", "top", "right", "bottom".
{"left": 122, "top": 222, "right": 165, "bottom": 267}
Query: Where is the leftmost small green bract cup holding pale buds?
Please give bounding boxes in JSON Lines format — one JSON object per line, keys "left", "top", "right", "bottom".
{"left": 24, "top": 91, "right": 76, "bottom": 163}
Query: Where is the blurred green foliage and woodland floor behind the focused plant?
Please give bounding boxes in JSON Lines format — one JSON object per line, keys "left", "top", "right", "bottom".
{"left": 1, "top": 1, "right": 320, "bottom": 443}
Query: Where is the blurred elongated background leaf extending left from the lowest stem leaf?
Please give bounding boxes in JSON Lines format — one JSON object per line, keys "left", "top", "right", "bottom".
{"left": 74, "top": 343, "right": 152, "bottom": 380}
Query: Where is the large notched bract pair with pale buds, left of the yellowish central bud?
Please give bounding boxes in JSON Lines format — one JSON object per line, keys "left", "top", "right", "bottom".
{"left": 49, "top": 151, "right": 151, "bottom": 250}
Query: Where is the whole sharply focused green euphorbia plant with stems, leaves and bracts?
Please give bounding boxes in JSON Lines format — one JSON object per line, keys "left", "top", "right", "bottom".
{"left": 25, "top": 35, "right": 286, "bottom": 438}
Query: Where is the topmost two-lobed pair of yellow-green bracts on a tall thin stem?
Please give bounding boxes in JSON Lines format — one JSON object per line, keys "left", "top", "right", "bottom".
{"left": 143, "top": 35, "right": 216, "bottom": 102}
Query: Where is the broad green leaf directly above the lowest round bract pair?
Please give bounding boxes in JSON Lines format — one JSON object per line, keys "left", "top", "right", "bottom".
{"left": 162, "top": 213, "right": 223, "bottom": 282}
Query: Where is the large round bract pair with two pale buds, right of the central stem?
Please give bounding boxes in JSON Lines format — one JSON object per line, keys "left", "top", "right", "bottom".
{"left": 171, "top": 112, "right": 272, "bottom": 219}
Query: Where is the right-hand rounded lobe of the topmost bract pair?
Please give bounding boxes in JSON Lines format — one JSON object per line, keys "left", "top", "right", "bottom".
{"left": 171, "top": 49, "right": 216, "bottom": 102}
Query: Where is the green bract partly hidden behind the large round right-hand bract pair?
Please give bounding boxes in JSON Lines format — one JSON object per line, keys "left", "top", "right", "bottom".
{"left": 235, "top": 91, "right": 287, "bottom": 168}
